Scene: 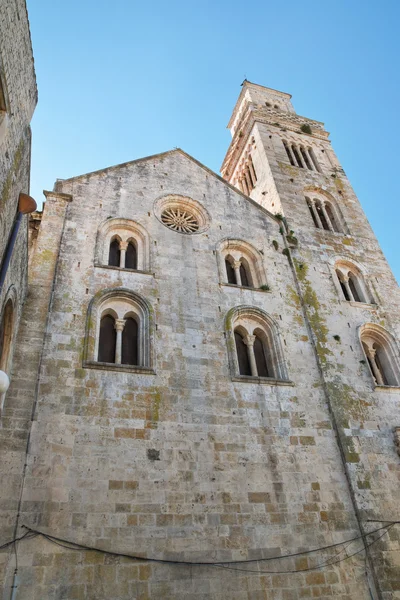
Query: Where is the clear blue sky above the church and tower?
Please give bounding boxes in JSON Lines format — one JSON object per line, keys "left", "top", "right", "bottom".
{"left": 28, "top": 0, "right": 400, "bottom": 280}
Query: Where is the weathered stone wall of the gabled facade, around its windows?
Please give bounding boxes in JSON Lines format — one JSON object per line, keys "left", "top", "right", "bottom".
{"left": 0, "top": 151, "right": 382, "bottom": 600}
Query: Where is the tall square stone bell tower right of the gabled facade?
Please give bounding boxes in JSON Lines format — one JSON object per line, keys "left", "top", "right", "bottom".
{"left": 221, "top": 80, "right": 400, "bottom": 600}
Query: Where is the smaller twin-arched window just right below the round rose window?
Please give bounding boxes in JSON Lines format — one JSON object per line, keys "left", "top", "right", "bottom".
{"left": 217, "top": 239, "right": 267, "bottom": 288}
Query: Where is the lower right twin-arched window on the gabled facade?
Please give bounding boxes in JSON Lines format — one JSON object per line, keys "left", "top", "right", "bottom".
{"left": 226, "top": 306, "right": 288, "bottom": 381}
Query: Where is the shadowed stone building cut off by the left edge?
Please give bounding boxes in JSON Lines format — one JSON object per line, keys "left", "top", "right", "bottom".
{"left": 0, "top": 0, "right": 37, "bottom": 406}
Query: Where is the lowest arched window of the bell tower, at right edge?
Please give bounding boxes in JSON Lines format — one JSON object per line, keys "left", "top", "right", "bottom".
{"left": 360, "top": 323, "right": 400, "bottom": 386}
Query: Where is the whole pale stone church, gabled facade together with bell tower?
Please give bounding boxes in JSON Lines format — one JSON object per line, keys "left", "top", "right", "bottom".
{"left": 0, "top": 82, "right": 400, "bottom": 600}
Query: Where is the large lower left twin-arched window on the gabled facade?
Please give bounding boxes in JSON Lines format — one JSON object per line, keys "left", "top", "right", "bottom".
{"left": 84, "top": 288, "right": 152, "bottom": 371}
